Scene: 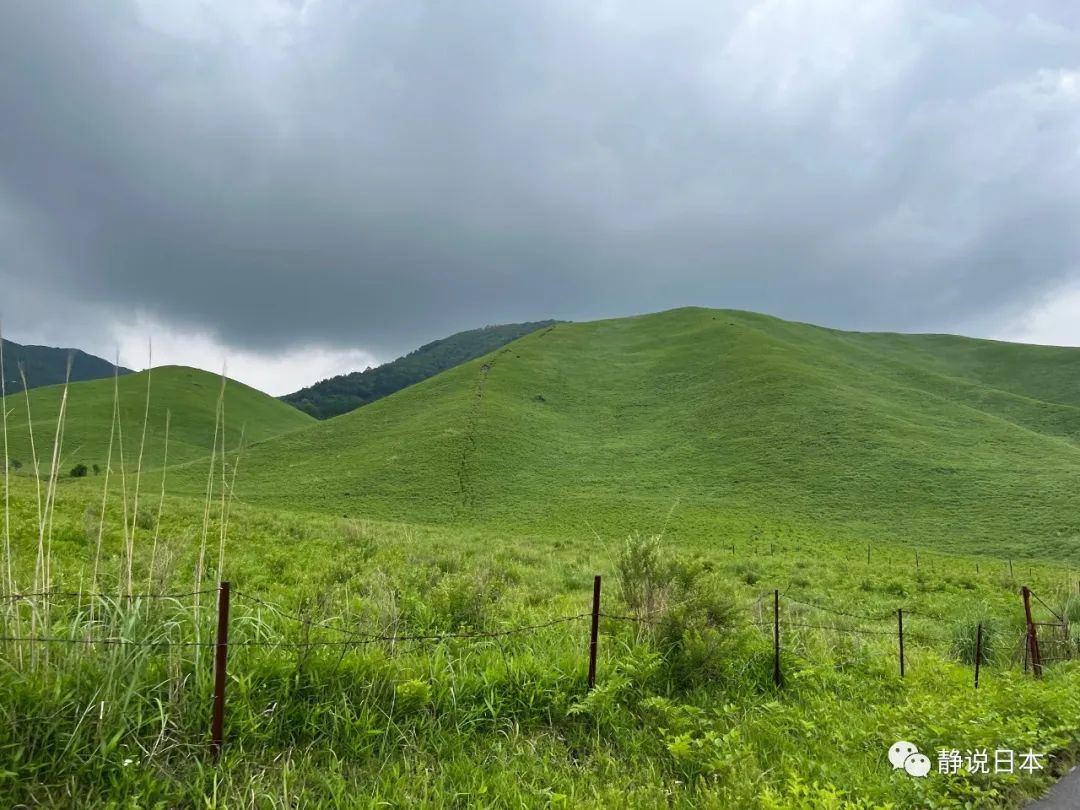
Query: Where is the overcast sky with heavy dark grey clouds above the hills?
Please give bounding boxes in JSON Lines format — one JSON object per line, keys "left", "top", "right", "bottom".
{"left": 0, "top": 0, "right": 1080, "bottom": 393}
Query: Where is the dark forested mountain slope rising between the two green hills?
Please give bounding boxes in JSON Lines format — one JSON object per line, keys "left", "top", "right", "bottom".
{"left": 281, "top": 321, "right": 559, "bottom": 419}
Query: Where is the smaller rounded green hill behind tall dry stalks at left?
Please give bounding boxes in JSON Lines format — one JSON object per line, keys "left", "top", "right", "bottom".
{"left": 8, "top": 366, "right": 314, "bottom": 473}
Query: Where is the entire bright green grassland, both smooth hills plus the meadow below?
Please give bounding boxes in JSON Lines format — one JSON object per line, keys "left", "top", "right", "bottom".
{"left": 0, "top": 310, "right": 1080, "bottom": 810}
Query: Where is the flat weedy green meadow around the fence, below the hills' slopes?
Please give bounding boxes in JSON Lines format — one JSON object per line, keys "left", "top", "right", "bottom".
{"left": 0, "top": 482, "right": 1080, "bottom": 810}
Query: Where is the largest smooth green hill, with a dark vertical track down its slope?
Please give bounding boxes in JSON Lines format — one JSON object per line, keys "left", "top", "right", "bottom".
{"left": 212, "top": 309, "right": 1080, "bottom": 554}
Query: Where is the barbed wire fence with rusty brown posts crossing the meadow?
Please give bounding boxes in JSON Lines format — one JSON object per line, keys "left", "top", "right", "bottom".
{"left": 0, "top": 576, "right": 1080, "bottom": 754}
